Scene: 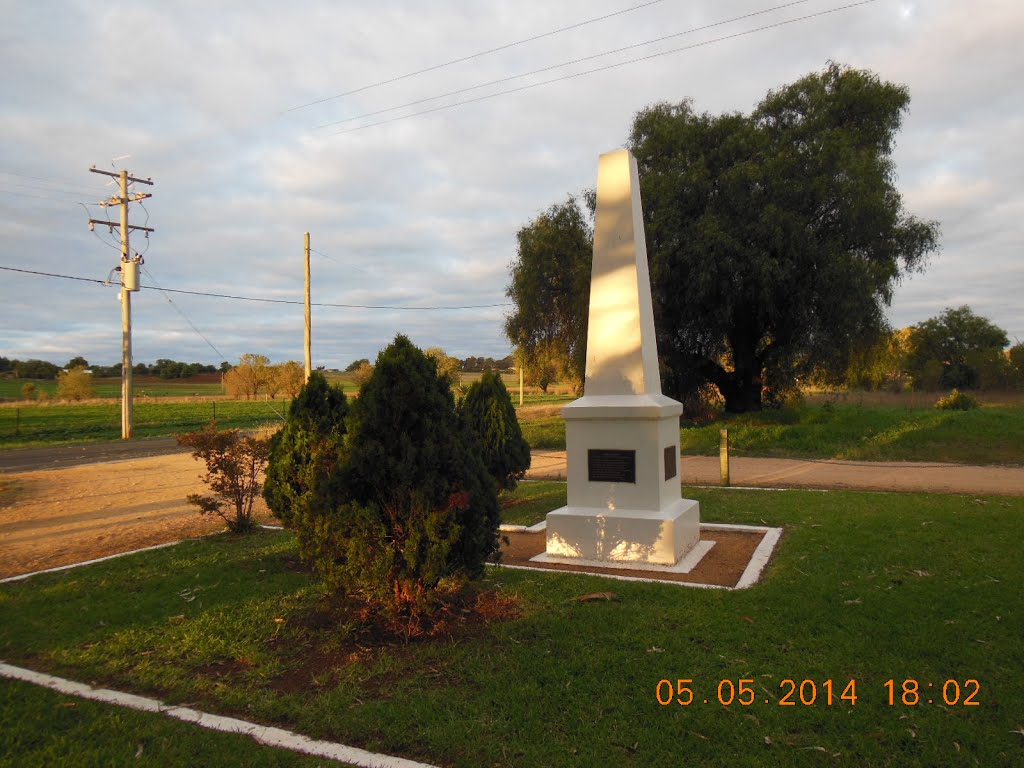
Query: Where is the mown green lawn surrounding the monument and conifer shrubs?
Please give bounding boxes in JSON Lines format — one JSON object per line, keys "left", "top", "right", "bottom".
{"left": 0, "top": 483, "right": 1024, "bottom": 768}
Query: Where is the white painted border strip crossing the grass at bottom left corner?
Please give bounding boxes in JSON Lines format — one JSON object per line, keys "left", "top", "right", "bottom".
{"left": 0, "top": 662, "right": 434, "bottom": 768}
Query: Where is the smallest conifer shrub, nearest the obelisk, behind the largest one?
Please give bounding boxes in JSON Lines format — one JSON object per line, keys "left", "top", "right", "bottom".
{"left": 459, "top": 371, "right": 530, "bottom": 490}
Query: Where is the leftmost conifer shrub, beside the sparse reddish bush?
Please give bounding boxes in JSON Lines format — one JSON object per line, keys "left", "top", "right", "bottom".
{"left": 263, "top": 371, "right": 348, "bottom": 557}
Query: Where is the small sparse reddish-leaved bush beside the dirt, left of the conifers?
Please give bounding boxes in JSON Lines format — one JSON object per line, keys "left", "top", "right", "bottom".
{"left": 174, "top": 422, "right": 270, "bottom": 534}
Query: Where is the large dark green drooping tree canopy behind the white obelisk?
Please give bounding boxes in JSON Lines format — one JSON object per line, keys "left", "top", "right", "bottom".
{"left": 506, "top": 63, "right": 938, "bottom": 413}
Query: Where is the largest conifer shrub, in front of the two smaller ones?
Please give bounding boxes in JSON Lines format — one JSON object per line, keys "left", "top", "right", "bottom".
{"left": 292, "top": 335, "right": 499, "bottom": 634}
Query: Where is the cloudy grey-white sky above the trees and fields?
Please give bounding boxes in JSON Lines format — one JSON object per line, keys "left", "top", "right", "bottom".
{"left": 0, "top": 0, "right": 1024, "bottom": 368}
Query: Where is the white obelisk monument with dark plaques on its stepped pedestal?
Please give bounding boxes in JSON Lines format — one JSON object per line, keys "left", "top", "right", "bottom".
{"left": 541, "top": 150, "right": 700, "bottom": 565}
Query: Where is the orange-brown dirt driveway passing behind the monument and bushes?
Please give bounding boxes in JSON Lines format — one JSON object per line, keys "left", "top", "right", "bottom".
{"left": 0, "top": 451, "right": 1024, "bottom": 578}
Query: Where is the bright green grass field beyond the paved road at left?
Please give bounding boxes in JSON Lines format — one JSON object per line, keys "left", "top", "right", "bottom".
{"left": 0, "top": 399, "right": 288, "bottom": 449}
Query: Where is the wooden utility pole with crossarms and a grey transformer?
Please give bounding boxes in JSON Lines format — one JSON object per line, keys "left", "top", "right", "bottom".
{"left": 89, "top": 166, "right": 153, "bottom": 440}
